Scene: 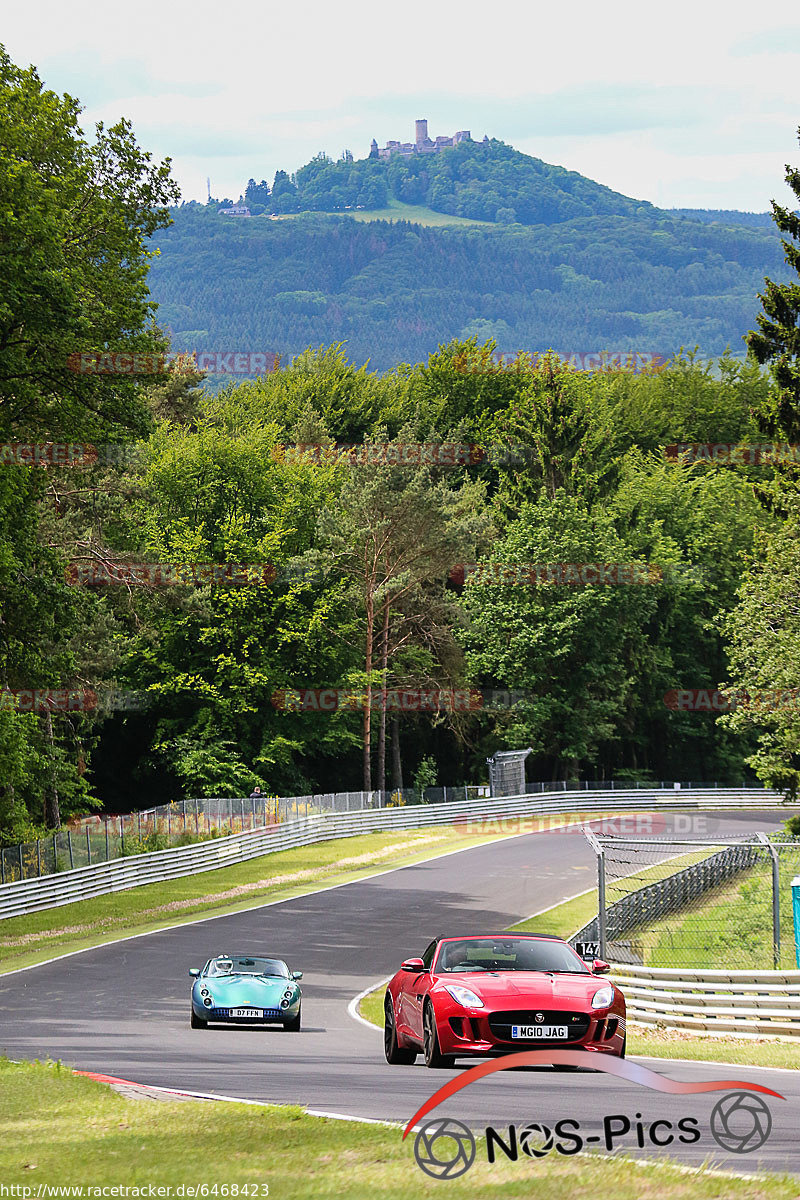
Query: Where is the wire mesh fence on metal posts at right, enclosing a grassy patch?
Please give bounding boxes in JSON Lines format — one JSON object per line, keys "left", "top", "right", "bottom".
{"left": 572, "top": 832, "right": 800, "bottom": 971}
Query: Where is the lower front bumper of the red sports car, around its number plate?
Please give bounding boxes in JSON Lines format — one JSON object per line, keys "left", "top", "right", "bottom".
{"left": 437, "top": 1010, "right": 625, "bottom": 1057}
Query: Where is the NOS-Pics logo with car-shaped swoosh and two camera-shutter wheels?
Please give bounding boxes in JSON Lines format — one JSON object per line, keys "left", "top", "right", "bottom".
{"left": 403, "top": 1050, "right": 784, "bottom": 1180}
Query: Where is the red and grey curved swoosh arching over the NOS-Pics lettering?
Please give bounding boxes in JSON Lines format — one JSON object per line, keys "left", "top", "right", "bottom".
{"left": 403, "top": 1050, "right": 786, "bottom": 1139}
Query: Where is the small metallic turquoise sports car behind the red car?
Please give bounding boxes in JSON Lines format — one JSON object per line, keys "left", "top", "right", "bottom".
{"left": 190, "top": 954, "right": 302, "bottom": 1032}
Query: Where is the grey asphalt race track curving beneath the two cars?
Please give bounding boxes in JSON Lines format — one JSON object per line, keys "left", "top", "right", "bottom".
{"left": 0, "top": 809, "right": 800, "bottom": 1174}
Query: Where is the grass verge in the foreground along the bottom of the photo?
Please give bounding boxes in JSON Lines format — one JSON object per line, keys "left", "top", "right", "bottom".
{"left": 0, "top": 1060, "right": 798, "bottom": 1200}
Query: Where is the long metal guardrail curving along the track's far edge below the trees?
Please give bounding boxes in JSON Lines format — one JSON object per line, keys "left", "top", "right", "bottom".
{"left": 0, "top": 788, "right": 782, "bottom": 919}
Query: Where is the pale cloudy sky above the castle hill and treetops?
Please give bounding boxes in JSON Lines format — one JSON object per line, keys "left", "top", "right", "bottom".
{"left": 0, "top": 0, "right": 800, "bottom": 211}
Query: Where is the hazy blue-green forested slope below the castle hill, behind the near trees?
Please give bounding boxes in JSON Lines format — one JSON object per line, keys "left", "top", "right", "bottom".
{"left": 150, "top": 202, "right": 784, "bottom": 370}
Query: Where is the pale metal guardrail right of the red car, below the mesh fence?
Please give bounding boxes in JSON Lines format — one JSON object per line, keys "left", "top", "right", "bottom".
{"left": 612, "top": 962, "right": 800, "bottom": 1037}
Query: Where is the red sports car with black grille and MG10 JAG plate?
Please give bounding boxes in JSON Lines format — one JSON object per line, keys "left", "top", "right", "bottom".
{"left": 384, "top": 934, "right": 625, "bottom": 1069}
